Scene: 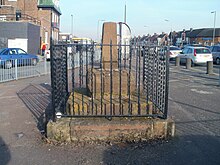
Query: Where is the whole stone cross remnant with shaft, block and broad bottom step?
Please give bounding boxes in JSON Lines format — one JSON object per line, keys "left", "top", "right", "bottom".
{"left": 67, "top": 22, "right": 152, "bottom": 115}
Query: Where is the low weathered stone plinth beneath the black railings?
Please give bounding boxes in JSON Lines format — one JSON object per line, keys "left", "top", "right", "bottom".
{"left": 47, "top": 118, "right": 175, "bottom": 142}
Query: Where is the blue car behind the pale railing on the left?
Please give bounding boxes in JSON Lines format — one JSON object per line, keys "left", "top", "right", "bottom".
{"left": 0, "top": 48, "right": 39, "bottom": 69}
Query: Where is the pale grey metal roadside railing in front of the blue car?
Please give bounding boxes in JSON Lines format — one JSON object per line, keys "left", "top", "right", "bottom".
{"left": 0, "top": 58, "right": 50, "bottom": 82}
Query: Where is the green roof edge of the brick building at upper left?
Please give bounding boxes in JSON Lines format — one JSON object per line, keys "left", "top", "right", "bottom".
{"left": 38, "top": 0, "right": 62, "bottom": 15}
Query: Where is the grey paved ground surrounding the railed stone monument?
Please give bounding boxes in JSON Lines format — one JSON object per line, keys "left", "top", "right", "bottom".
{"left": 0, "top": 64, "right": 220, "bottom": 165}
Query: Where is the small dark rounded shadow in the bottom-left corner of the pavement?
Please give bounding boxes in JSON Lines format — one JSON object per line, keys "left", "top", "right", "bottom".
{"left": 0, "top": 136, "right": 11, "bottom": 165}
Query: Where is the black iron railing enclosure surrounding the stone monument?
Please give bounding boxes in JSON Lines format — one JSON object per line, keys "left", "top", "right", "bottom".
{"left": 51, "top": 43, "right": 169, "bottom": 119}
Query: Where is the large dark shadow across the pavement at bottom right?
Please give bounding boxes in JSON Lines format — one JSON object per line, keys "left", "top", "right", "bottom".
{"left": 103, "top": 135, "right": 220, "bottom": 165}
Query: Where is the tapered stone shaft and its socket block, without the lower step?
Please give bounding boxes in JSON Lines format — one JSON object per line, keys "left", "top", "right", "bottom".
{"left": 87, "top": 22, "right": 135, "bottom": 99}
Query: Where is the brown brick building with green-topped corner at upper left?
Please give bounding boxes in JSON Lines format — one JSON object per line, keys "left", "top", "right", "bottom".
{"left": 0, "top": 0, "right": 61, "bottom": 46}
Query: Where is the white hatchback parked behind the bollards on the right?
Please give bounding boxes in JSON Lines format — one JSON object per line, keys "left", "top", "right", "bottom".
{"left": 178, "top": 46, "right": 213, "bottom": 65}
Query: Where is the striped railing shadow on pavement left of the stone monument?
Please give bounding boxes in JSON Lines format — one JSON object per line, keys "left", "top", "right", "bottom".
{"left": 17, "top": 84, "right": 52, "bottom": 131}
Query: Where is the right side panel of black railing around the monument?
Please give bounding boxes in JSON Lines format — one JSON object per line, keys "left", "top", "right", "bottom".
{"left": 143, "top": 46, "right": 169, "bottom": 118}
